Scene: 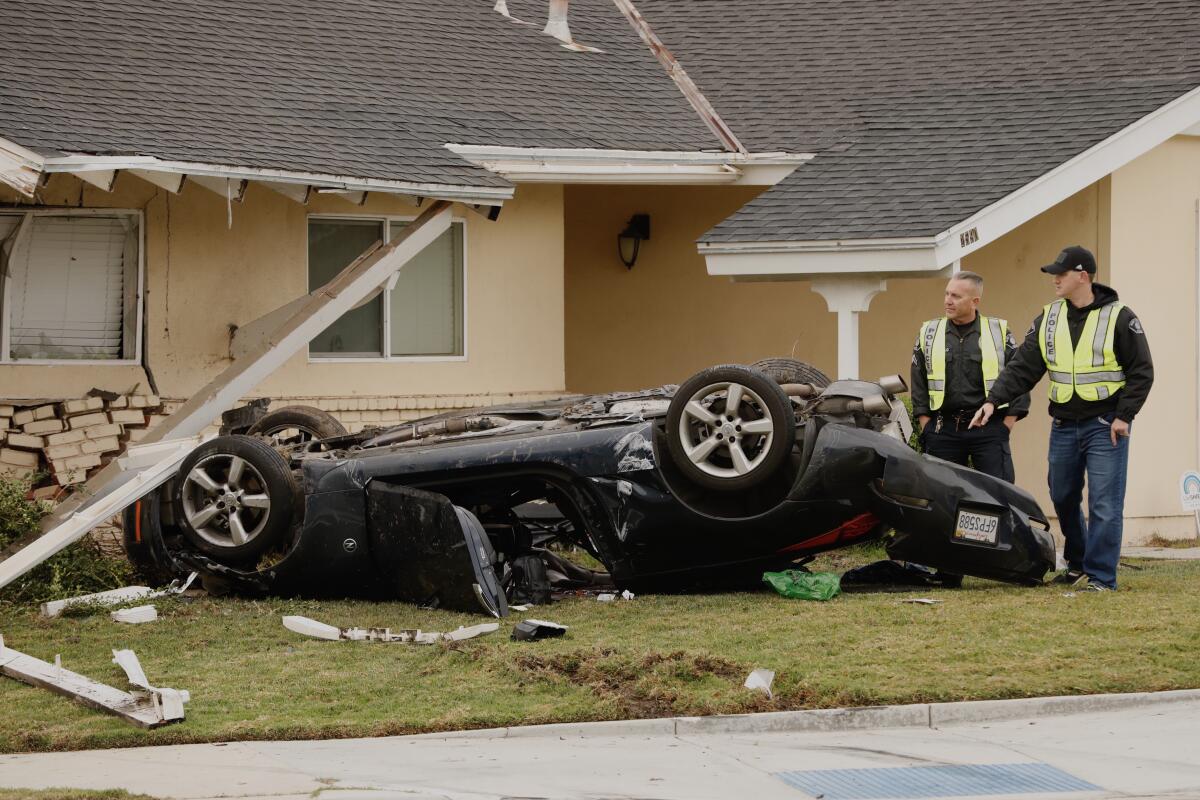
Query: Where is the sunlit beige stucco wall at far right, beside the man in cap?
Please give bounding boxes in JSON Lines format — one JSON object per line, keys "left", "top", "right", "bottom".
{"left": 1111, "top": 137, "right": 1200, "bottom": 536}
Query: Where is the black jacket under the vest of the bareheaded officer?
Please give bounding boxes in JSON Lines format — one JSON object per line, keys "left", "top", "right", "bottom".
{"left": 910, "top": 314, "right": 1030, "bottom": 417}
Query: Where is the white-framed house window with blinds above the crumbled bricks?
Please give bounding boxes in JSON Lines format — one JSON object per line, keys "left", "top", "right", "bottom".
{"left": 0, "top": 210, "right": 140, "bottom": 362}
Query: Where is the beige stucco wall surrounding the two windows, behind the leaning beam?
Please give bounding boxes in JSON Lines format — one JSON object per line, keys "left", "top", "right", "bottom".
{"left": 0, "top": 174, "right": 564, "bottom": 410}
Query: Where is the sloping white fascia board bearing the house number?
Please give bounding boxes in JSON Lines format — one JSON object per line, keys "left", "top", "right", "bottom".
{"left": 937, "top": 88, "right": 1200, "bottom": 264}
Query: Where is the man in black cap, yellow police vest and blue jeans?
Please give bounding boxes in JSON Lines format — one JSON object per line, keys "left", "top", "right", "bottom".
{"left": 971, "top": 245, "right": 1154, "bottom": 591}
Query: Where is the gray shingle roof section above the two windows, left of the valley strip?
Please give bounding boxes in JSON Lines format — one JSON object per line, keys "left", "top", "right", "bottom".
{"left": 0, "top": 0, "right": 719, "bottom": 186}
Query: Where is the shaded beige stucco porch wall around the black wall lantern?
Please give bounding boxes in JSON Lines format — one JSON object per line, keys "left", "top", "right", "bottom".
{"left": 566, "top": 186, "right": 836, "bottom": 392}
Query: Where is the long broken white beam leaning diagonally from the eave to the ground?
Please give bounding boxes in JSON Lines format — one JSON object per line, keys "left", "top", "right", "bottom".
{"left": 9, "top": 200, "right": 452, "bottom": 588}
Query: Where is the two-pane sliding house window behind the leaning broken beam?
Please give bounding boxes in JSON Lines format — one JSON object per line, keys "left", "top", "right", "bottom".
{"left": 308, "top": 217, "right": 466, "bottom": 359}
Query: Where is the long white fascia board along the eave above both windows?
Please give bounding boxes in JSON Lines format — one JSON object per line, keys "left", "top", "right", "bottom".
{"left": 44, "top": 155, "right": 514, "bottom": 205}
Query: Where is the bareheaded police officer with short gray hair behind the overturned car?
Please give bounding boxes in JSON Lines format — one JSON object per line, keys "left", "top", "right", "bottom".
{"left": 911, "top": 272, "right": 1030, "bottom": 481}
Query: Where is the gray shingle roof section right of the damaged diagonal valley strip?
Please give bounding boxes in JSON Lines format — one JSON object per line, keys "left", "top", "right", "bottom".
{"left": 637, "top": 0, "right": 1200, "bottom": 242}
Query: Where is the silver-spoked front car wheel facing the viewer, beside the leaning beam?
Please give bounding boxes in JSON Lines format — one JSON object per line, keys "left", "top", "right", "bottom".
{"left": 175, "top": 435, "right": 296, "bottom": 561}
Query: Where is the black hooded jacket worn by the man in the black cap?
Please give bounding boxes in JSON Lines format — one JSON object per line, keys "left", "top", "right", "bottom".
{"left": 988, "top": 283, "right": 1154, "bottom": 422}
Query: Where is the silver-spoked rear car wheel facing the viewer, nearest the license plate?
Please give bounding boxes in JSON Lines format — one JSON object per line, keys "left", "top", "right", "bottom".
{"left": 667, "top": 365, "right": 796, "bottom": 492}
